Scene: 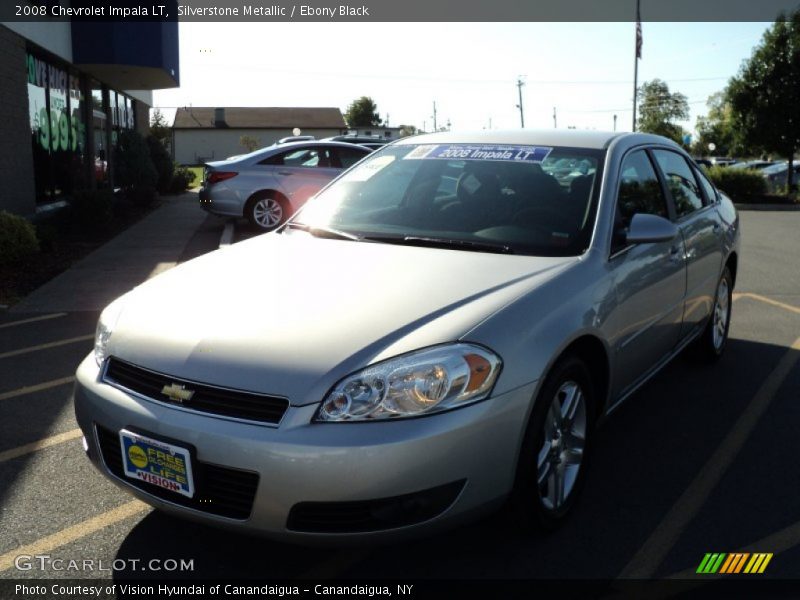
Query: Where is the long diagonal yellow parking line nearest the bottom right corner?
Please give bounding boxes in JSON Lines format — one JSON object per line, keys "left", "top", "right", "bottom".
{"left": 618, "top": 338, "right": 800, "bottom": 579}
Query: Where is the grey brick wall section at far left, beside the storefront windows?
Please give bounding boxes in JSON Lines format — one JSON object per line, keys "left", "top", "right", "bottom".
{"left": 0, "top": 25, "right": 36, "bottom": 215}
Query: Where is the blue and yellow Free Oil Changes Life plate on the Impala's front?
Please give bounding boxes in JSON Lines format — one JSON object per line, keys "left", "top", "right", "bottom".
{"left": 119, "top": 429, "right": 194, "bottom": 498}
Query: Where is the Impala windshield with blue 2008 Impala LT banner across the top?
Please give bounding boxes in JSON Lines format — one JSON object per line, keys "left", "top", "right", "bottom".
{"left": 288, "top": 144, "right": 604, "bottom": 256}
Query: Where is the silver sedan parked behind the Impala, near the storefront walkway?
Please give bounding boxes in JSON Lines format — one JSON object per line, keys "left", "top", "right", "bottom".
{"left": 200, "top": 140, "right": 371, "bottom": 231}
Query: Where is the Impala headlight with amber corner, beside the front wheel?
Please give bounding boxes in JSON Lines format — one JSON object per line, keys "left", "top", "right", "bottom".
{"left": 314, "top": 344, "right": 502, "bottom": 422}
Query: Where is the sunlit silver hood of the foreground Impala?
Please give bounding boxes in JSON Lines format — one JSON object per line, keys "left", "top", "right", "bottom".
{"left": 108, "top": 232, "right": 577, "bottom": 405}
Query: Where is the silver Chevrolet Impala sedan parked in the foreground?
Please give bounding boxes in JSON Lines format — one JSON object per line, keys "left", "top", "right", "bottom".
{"left": 75, "top": 131, "right": 740, "bottom": 541}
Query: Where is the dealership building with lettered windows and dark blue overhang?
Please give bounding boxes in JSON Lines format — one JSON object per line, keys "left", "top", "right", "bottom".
{"left": 0, "top": 19, "right": 180, "bottom": 216}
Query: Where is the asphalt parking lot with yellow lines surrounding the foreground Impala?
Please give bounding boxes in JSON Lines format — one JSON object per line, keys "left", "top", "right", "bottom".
{"left": 0, "top": 212, "right": 800, "bottom": 592}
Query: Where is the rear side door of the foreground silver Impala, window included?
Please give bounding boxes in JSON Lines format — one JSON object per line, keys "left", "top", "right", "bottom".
{"left": 653, "top": 149, "right": 723, "bottom": 338}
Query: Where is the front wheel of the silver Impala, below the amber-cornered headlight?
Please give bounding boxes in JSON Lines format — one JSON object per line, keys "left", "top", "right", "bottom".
{"left": 512, "top": 356, "right": 595, "bottom": 531}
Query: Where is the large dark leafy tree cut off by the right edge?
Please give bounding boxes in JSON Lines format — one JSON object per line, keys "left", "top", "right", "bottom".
{"left": 727, "top": 9, "right": 800, "bottom": 191}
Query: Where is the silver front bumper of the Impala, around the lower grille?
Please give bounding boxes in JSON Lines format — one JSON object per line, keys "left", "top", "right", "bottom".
{"left": 75, "top": 355, "right": 535, "bottom": 542}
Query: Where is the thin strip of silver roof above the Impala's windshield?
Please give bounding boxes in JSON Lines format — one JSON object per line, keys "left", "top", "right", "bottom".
{"left": 395, "top": 129, "right": 675, "bottom": 150}
